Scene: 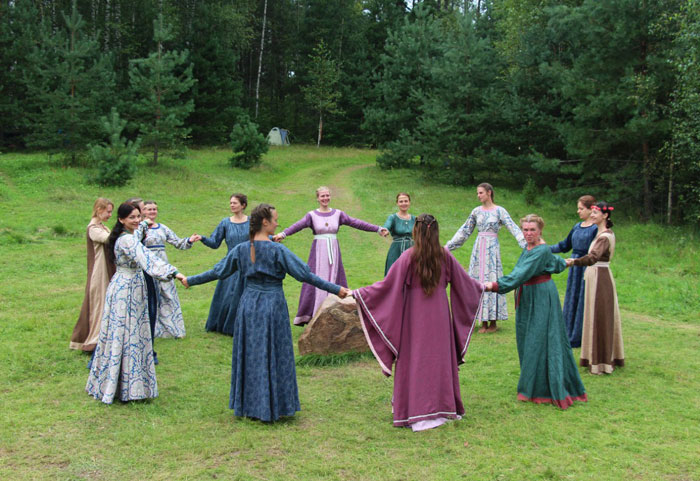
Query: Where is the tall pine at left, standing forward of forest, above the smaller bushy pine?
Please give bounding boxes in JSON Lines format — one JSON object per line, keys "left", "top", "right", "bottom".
{"left": 129, "top": 14, "right": 196, "bottom": 165}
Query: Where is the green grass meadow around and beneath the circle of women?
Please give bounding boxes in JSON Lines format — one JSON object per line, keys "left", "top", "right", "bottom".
{"left": 0, "top": 147, "right": 700, "bottom": 481}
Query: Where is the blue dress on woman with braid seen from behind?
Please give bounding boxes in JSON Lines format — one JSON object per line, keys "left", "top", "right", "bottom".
{"left": 187, "top": 241, "right": 340, "bottom": 421}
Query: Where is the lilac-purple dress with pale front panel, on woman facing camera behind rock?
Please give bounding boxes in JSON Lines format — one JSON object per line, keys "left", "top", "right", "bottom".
{"left": 282, "top": 209, "right": 381, "bottom": 326}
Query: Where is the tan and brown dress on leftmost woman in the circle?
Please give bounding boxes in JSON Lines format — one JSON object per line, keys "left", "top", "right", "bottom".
{"left": 69, "top": 218, "right": 115, "bottom": 351}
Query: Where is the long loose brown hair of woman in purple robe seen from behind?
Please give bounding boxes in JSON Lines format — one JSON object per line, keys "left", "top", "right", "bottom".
{"left": 411, "top": 214, "right": 445, "bottom": 296}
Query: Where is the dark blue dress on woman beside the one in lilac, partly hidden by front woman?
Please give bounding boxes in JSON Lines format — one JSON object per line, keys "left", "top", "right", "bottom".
{"left": 202, "top": 217, "right": 250, "bottom": 336}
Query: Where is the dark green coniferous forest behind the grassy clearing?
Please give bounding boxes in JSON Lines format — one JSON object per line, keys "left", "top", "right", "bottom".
{"left": 0, "top": 0, "right": 700, "bottom": 224}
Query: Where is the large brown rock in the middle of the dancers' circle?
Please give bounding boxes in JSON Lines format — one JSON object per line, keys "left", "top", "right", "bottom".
{"left": 299, "top": 294, "right": 369, "bottom": 356}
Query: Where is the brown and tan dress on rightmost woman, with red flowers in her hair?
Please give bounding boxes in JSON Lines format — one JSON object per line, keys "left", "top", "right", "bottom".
{"left": 574, "top": 230, "right": 625, "bottom": 374}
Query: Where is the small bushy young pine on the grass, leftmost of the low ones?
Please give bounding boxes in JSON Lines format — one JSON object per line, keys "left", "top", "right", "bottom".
{"left": 90, "top": 108, "right": 140, "bottom": 186}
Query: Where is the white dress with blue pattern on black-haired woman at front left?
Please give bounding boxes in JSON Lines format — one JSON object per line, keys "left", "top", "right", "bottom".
{"left": 85, "top": 234, "right": 177, "bottom": 404}
